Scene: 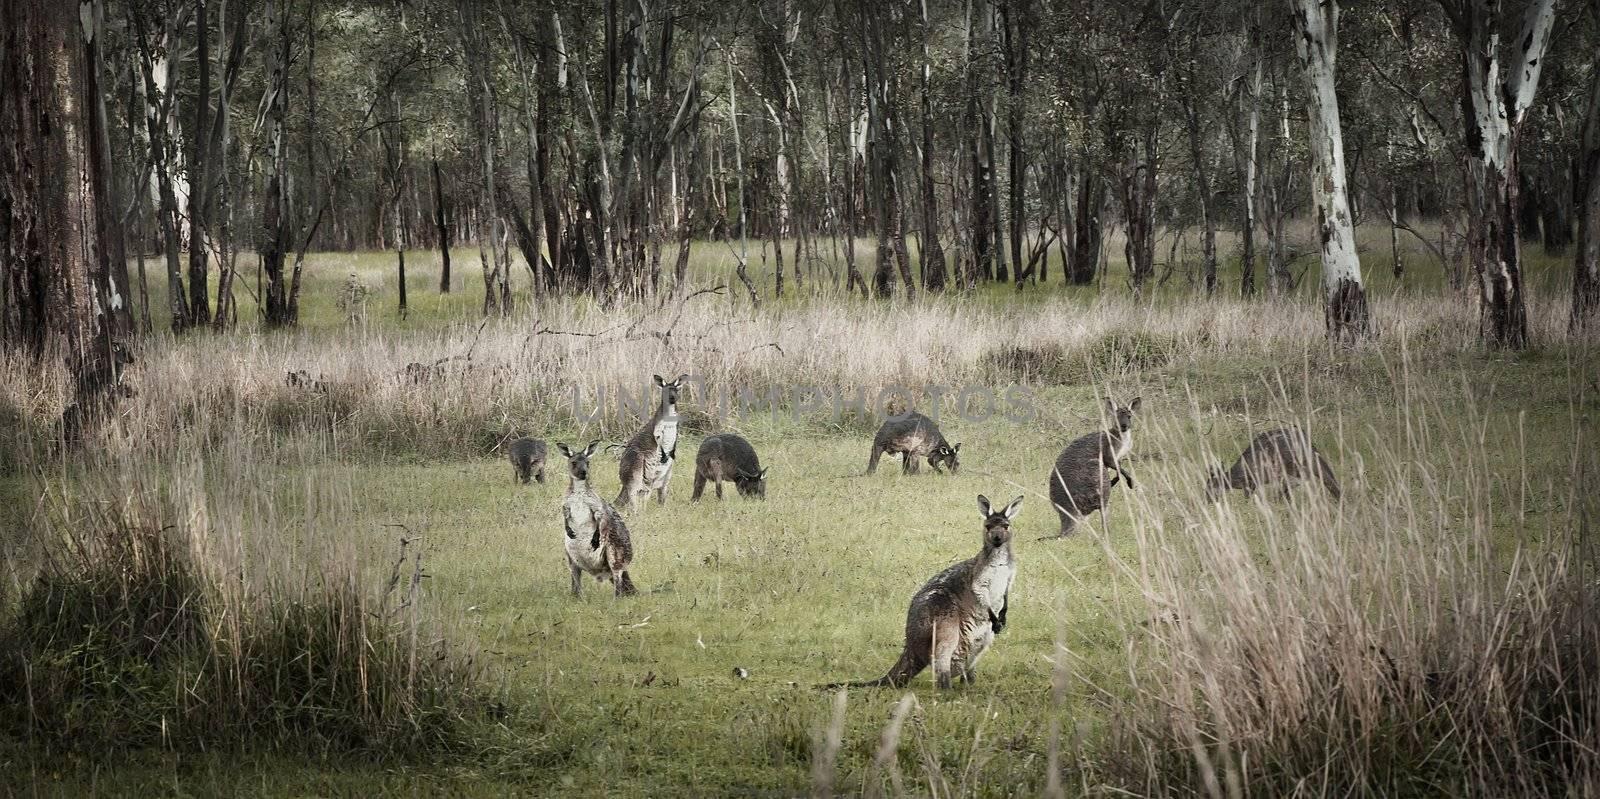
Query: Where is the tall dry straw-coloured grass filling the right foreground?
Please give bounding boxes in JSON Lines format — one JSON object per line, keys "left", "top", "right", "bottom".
{"left": 1066, "top": 346, "right": 1600, "bottom": 797}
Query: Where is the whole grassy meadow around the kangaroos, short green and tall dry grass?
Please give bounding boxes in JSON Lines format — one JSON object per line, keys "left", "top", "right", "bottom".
{"left": 0, "top": 228, "right": 1600, "bottom": 796}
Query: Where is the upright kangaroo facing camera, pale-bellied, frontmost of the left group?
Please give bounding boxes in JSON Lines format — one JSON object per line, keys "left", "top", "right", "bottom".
{"left": 555, "top": 440, "right": 638, "bottom": 597}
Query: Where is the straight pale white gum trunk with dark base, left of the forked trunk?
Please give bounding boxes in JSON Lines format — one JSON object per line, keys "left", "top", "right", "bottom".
{"left": 1290, "top": 0, "right": 1368, "bottom": 341}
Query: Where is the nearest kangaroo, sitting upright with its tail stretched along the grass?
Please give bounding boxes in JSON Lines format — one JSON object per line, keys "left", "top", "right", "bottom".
{"left": 829, "top": 495, "right": 1022, "bottom": 689}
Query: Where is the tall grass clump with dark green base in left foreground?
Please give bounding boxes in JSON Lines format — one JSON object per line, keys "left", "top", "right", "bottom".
{"left": 0, "top": 434, "right": 491, "bottom": 756}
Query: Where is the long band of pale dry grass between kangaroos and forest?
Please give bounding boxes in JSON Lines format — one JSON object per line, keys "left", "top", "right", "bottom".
{"left": 0, "top": 288, "right": 1566, "bottom": 464}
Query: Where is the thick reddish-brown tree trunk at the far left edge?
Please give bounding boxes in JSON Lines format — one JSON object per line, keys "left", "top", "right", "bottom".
{"left": 0, "top": 0, "right": 131, "bottom": 429}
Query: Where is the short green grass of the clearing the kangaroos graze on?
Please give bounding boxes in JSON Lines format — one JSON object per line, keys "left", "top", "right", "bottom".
{"left": 0, "top": 222, "right": 1595, "bottom": 796}
